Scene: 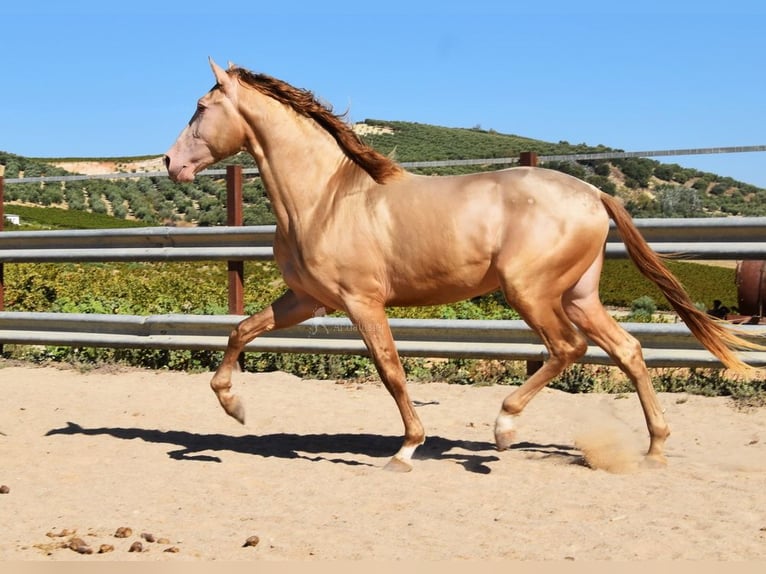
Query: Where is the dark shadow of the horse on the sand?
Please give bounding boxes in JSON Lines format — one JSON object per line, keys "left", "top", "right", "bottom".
{"left": 45, "top": 422, "right": 578, "bottom": 474}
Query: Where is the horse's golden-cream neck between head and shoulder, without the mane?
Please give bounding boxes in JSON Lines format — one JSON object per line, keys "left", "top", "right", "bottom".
{"left": 240, "top": 96, "right": 358, "bottom": 234}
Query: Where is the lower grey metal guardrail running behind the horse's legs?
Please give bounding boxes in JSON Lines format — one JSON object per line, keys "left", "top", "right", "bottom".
{"left": 0, "top": 312, "right": 766, "bottom": 368}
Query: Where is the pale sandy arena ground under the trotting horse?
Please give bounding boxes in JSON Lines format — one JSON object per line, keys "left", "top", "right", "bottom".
{"left": 0, "top": 361, "right": 766, "bottom": 562}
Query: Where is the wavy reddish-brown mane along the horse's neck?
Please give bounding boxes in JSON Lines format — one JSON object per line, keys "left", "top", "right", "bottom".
{"left": 228, "top": 67, "right": 404, "bottom": 183}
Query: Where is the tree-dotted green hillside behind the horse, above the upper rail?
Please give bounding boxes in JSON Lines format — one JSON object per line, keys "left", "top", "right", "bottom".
{"left": 0, "top": 119, "right": 766, "bottom": 231}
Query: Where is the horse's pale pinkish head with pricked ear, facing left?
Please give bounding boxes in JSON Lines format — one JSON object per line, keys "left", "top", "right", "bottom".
{"left": 165, "top": 58, "right": 247, "bottom": 181}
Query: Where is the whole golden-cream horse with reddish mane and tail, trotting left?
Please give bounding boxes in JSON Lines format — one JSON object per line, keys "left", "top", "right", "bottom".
{"left": 165, "top": 59, "right": 757, "bottom": 470}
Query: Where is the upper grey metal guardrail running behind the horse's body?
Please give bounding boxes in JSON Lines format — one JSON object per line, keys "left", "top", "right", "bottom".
{"left": 0, "top": 217, "right": 766, "bottom": 263}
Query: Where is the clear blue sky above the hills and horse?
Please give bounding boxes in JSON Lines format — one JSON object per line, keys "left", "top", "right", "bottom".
{"left": 0, "top": 0, "right": 766, "bottom": 187}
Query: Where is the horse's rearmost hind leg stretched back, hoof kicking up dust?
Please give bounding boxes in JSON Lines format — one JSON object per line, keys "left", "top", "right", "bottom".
{"left": 564, "top": 259, "right": 670, "bottom": 465}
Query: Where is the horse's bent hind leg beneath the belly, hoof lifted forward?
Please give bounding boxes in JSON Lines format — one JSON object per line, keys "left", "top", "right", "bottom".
{"left": 495, "top": 297, "right": 587, "bottom": 450}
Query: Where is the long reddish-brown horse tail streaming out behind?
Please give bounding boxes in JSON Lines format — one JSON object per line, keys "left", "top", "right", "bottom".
{"left": 601, "top": 193, "right": 766, "bottom": 375}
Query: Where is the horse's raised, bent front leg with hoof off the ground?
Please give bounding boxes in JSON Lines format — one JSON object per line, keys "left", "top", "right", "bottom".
{"left": 210, "top": 289, "right": 321, "bottom": 424}
